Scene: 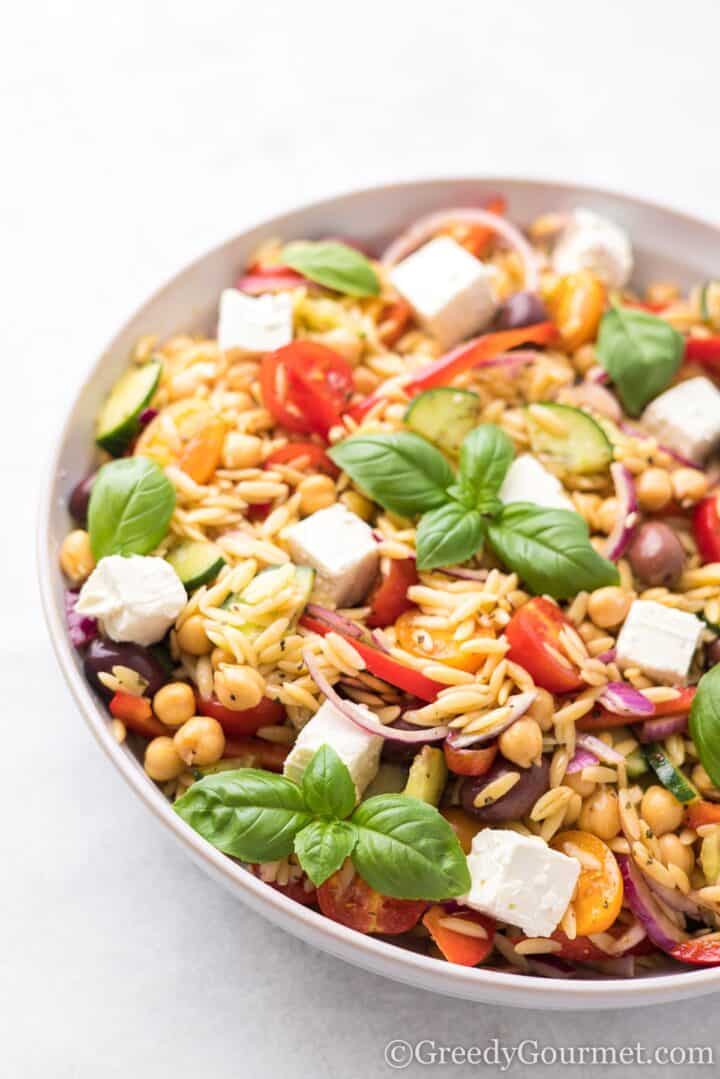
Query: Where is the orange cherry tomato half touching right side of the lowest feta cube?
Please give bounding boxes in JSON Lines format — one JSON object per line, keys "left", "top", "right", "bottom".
{"left": 551, "top": 831, "right": 624, "bottom": 937}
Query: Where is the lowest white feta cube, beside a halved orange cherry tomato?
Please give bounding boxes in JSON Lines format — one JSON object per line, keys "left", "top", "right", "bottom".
{"left": 464, "top": 828, "right": 580, "bottom": 937}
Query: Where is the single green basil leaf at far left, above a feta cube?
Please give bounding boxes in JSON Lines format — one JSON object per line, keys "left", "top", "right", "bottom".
{"left": 87, "top": 457, "right": 175, "bottom": 561}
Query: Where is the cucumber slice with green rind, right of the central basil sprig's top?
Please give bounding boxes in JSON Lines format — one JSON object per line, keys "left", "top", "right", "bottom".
{"left": 526, "top": 401, "right": 612, "bottom": 476}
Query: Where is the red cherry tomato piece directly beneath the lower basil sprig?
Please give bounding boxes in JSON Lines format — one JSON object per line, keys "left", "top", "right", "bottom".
{"left": 317, "top": 865, "right": 427, "bottom": 934}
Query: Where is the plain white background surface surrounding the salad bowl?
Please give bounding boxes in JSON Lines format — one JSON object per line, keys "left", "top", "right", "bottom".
{"left": 5, "top": 0, "right": 720, "bottom": 1079}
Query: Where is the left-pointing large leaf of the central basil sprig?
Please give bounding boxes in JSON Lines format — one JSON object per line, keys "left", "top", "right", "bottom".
{"left": 328, "top": 431, "right": 454, "bottom": 517}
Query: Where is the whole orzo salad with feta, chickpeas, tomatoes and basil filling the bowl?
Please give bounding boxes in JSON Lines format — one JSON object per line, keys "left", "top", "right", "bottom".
{"left": 59, "top": 197, "right": 720, "bottom": 978}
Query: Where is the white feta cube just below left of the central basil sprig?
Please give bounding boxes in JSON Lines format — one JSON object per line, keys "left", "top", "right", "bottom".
{"left": 285, "top": 503, "right": 380, "bottom": 606}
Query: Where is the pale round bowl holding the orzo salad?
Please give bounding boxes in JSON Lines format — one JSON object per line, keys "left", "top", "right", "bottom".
{"left": 39, "top": 178, "right": 720, "bottom": 1009}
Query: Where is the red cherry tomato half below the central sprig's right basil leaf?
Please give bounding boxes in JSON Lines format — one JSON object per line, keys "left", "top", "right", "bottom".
{"left": 505, "top": 596, "right": 585, "bottom": 693}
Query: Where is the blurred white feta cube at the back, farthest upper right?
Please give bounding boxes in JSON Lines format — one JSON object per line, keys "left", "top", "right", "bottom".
{"left": 551, "top": 209, "right": 633, "bottom": 288}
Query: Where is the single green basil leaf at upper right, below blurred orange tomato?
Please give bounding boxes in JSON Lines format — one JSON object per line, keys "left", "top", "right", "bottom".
{"left": 597, "top": 308, "right": 683, "bottom": 415}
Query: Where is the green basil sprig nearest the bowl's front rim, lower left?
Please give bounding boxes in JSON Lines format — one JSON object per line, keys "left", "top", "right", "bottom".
{"left": 175, "top": 746, "right": 471, "bottom": 901}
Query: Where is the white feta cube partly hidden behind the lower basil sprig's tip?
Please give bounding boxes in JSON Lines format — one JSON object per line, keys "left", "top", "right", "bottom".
{"left": 283, "top": 700, "right": 384, "bottom": 801}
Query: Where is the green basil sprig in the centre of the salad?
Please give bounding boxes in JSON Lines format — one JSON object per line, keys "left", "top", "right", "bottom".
{"left": 329, "top": 424, "right": 619, "bottom": 600}
